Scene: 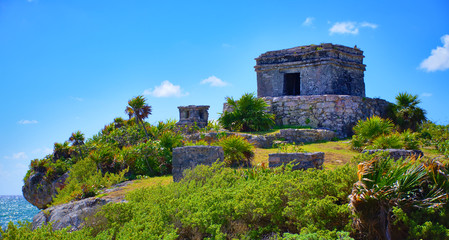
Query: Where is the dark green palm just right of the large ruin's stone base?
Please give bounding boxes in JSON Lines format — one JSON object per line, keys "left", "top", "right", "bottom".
{"left": 390, "top": 92, "right": 426, "bottom": 131}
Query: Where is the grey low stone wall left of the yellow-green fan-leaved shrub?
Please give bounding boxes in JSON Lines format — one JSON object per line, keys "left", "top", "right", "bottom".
{"left": 172, "top": 146, "right": 224, "bottom": 182}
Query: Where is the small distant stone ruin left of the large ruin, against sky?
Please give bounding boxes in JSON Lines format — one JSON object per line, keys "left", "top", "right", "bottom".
{"left": 176, "top": 105, "right": 210, "bottom": 128}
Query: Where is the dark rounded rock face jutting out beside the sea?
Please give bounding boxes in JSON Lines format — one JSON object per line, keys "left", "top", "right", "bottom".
{"left": 22, "top": 171, "right": 69, "bottom": 209}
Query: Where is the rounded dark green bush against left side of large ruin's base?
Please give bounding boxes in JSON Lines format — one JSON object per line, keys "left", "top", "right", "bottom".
{"left": 218, "top": 93, "right": 274, "bottom": 132}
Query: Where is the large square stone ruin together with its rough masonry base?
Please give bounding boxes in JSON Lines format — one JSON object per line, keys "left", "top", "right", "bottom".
{"left": 248, "top": 43, "right": 389, "bottom": 138}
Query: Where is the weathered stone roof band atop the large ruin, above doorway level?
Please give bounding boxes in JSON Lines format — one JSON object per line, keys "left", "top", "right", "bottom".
{"left": 255, "top": 43, "right": 365, "bottom": 71}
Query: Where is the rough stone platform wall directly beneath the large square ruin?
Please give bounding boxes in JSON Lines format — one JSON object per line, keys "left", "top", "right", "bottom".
{"left": 263, "top": 95, "right": 389, "bottom": 138}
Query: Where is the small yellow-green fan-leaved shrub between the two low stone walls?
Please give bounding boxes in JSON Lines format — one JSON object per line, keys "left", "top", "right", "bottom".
{"left": 216, "top": 135, "right": 254, "bottom": 166}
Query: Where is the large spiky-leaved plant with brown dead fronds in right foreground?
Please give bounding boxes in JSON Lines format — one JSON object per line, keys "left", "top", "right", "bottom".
{"left": 349, "top": 156, "right": 448, "bottom": 239}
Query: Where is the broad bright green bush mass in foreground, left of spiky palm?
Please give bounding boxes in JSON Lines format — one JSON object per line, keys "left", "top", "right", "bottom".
{"left": 81, "top": 164, "right": 356, "bottom": 239}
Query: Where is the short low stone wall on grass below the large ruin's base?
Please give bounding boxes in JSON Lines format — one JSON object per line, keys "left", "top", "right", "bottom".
{"left": 268, "top": 152, "right": 324, "bottom": 170}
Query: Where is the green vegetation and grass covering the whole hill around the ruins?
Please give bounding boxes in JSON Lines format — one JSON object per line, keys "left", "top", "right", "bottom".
{"left": 0, "top": 93, "right": 449, "bottom": 239}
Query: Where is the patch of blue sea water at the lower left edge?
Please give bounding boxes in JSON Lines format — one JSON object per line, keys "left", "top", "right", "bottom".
{"left": 0, "top": 195, "right": 39, "bottom": 229}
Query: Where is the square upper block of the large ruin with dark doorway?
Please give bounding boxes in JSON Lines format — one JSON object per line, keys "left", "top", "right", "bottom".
{"left": 255, "top": 43, "right": 365, "bottom": 97}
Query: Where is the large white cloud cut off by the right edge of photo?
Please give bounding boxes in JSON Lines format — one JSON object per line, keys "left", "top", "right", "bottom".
{"left": 419, "top": 34, "right": 449, "bottom": 72}
